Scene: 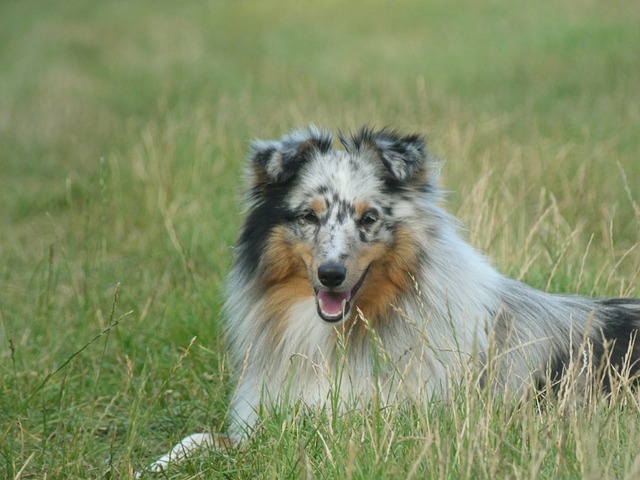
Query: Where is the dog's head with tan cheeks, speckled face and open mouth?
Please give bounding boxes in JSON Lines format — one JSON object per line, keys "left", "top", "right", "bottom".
{"left": 238, "top": 127, "right": 436, "bottom": 322}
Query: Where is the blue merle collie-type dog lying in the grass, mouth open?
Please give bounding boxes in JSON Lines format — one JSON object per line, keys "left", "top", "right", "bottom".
{"left": 144, "top": 126, "right": 640, "bottom": 471}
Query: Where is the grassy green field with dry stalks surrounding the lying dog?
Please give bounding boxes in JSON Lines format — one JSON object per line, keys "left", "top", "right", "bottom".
{"left": 0, "top": 0, "right": 640, "bottom": 480}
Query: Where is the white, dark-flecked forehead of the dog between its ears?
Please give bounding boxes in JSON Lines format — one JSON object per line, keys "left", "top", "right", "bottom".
{"left": 292, "top": 150, "right": 382, "bottom": 203}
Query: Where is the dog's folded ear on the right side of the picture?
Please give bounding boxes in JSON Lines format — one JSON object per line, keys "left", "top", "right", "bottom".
{"left": 340, "top": 127, "right": 428, "bottom": 184}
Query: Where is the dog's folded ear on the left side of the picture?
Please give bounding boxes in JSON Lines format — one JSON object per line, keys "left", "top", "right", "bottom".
{"left": 249, "top": 126, "right": 333, "bottom": 185}
